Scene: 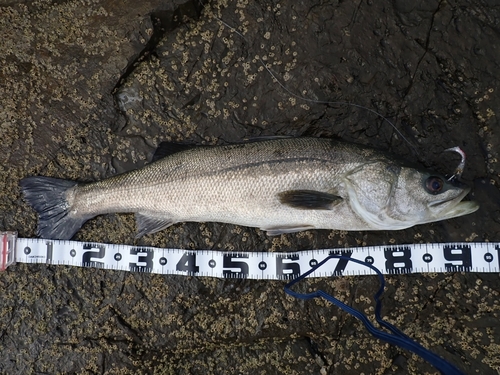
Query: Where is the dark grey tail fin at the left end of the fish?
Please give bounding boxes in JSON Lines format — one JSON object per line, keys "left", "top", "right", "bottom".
{"left": 19, "top": 176, "right": 90, "bottom": 240}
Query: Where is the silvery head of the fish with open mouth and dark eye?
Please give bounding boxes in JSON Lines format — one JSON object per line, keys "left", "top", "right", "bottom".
{"left": 346, "top": 162, "right": 479, "bottom": 230}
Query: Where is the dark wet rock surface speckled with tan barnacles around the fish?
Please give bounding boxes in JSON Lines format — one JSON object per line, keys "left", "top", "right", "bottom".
{"left": 0, "top": 0, "right": 500, "bottom": 374}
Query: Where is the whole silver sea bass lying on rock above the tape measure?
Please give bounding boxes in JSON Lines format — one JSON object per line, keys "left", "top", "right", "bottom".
{"left": 20, "top": 138, "right": 478, "bottom": 239}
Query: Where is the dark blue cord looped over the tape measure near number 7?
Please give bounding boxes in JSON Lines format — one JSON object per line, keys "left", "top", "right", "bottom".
{"left": 285, "top": 254, "right": 465, "bottom": 375}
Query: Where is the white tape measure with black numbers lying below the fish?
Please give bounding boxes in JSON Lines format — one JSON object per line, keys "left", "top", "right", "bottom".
{"left": 0, "top": 232, "right": 500, "bottom": 280}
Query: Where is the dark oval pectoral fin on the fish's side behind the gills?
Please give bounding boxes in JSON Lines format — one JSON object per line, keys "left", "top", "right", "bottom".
{"left": 278, "top": 190, "right": 343, "bottom": 210}
